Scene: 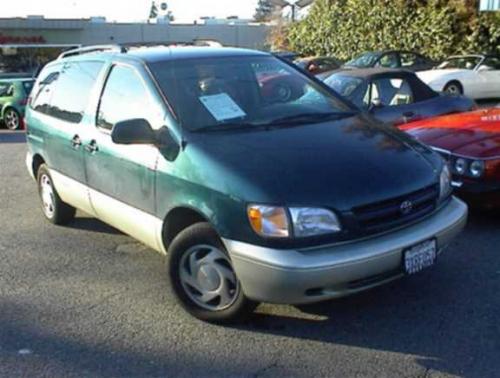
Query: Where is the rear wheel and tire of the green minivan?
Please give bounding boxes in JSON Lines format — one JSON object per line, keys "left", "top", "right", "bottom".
{"left": 37, "top": 164, "right": 76, "bottom": 225}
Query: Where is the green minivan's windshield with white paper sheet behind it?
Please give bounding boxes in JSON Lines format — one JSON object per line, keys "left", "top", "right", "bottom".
{"left": 150, "top": 56, "right": 355, "bottom": 131}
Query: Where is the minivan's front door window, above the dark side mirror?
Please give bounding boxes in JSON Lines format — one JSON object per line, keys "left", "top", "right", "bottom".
{"left": 97, "top": 65, "right": 153, "bottom": 130}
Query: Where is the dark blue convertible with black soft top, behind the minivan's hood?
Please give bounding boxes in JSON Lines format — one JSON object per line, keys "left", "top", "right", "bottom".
{"left": 322, "top": 68, "right": 476, "bottom": 125}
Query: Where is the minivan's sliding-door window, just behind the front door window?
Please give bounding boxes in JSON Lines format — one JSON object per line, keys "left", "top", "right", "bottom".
{"left": 50, "top": 62, "right": 103, "bottom": 123}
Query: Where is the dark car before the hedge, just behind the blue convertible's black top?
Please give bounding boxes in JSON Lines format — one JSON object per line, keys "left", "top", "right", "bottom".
{"left": 344, "top": 50, "right": 435, "bottom": 71}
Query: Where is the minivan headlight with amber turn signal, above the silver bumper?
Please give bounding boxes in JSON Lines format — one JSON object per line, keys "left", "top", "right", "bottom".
{"left": 247, "top": 205, "right": 342, "bottom": 238}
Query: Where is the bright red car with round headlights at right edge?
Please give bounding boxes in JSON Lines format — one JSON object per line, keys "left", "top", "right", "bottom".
{"left": 400, "top": 107, "right": 500, "bottom": 208}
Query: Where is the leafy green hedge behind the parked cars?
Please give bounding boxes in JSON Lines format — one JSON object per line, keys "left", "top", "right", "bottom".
{"left": 278, "top": 0, "right": 500, "bottom": 59}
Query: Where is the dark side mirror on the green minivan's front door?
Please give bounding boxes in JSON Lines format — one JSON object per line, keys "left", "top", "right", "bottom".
{"left": 111, "top": 118, "right": 158, "bottom": 144}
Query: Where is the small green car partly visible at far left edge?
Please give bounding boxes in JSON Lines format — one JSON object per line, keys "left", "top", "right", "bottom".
{"left": 0, "top": 78, "right": 35, "bottom": 130}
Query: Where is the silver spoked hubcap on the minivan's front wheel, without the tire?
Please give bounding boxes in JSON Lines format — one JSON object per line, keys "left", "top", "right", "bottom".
{"left": 179, "top": 245, "right": 241, "bottom": 311}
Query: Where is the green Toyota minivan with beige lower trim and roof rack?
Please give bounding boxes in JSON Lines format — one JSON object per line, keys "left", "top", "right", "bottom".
{"left": 26, "top": 46, "right": 467, "bottom": 322}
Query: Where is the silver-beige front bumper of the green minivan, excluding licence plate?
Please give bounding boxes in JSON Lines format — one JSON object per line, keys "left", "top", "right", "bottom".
{"left": 223, "top": 197, "right": 467, "bottom": 304}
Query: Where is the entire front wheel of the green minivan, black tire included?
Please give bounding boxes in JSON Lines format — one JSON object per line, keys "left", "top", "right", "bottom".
{"left": 167, "top": 223, "right": 256, "bottom": 323}
